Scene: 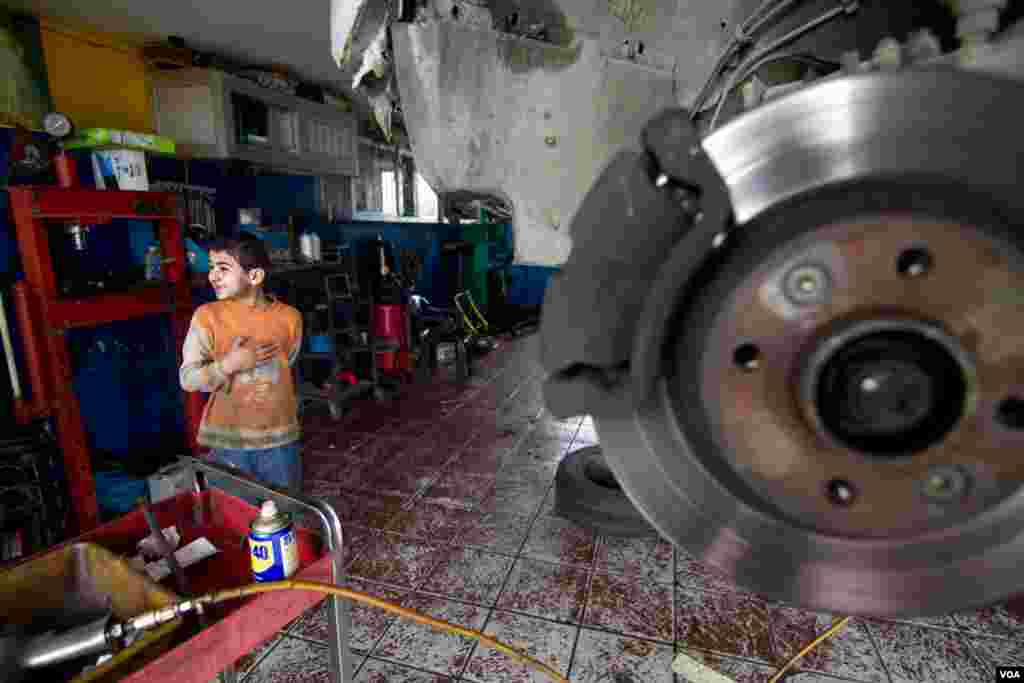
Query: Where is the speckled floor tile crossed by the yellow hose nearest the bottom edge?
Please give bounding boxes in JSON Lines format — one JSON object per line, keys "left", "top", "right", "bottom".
{"left": 463, "top": 610, "right": 580, "bottom": 683}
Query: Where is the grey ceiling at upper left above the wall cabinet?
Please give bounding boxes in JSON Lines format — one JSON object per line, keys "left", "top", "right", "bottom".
{"left": 0, "top": 0, "right": 350, "bottom": 94}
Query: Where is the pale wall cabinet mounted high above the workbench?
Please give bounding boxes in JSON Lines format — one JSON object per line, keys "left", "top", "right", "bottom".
{"left": 153, "top": 69, "right": 358, "bottom": 176}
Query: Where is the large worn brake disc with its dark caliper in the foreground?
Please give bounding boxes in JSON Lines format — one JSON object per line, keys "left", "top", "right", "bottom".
{"left": 542, "top": 71, "right": 1024, "bottom": 616}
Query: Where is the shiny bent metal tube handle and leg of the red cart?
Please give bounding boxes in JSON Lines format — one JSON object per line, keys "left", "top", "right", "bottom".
{"left": 181, "top": 456, "right": 352, "bottom": 683}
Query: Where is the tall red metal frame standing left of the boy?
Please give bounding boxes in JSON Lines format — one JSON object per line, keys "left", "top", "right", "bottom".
{"left": 7, "top": 186, "right": 201, "bottom": 532}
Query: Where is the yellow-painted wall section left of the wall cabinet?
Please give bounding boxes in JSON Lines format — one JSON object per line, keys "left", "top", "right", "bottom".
{"left": 40, "top": 18, "right": 156, "bottom": 133}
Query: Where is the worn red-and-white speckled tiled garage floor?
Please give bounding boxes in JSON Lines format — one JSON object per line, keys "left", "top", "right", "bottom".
{"left": 239, "top": 338, "right": 1024, "bottom": 683}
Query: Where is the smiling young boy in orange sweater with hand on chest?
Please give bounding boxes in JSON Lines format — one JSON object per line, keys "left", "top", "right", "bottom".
{"left": 180, "top": 236, "right": 302, "bottom": 490}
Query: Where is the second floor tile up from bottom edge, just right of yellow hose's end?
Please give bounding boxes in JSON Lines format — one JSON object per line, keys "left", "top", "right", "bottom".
{"left": 584, "top": 573, "right": 673, "bottom": 643}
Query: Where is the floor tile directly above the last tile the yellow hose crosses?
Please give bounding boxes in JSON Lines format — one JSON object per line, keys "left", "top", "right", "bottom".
{"left": 498, "top": 557, "right": 589, "bottom": 622}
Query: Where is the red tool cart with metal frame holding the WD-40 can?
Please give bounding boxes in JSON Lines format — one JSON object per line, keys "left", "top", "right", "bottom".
{"left": 47, "top": 458, "right": 352, "bottom": 683}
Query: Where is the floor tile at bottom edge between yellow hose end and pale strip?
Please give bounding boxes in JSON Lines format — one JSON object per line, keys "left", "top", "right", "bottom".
{"left": 569, "top": 629, "right": 673, "bottom": 683}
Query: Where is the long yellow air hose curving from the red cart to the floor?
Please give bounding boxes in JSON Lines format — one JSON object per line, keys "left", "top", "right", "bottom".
{"left": 193, "top": 580, "right": 568, "bottom": 683}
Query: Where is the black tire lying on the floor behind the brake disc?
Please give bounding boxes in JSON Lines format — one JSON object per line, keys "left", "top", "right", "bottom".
{"left": 555, "top": 445, "right": 657, "bottom": 538}
